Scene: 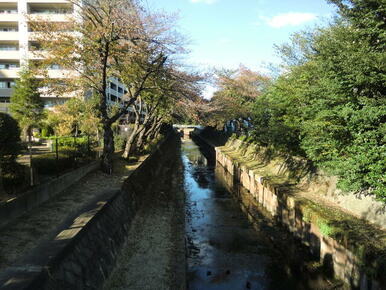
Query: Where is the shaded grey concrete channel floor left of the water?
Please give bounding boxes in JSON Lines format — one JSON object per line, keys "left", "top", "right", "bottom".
{"left": 103, "top": 160, "right": 186, "bottom": 290}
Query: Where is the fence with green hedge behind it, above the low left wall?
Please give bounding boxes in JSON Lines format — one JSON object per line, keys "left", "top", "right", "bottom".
{"left": 0, "top": 136, "right": 100, "bottom": 201}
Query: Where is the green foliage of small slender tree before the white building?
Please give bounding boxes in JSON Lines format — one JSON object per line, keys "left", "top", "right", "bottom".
{"left": 9, "top": 68, "right": 44, "bottom": 132}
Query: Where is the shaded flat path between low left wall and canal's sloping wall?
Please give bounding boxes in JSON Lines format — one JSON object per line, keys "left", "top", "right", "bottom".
{"left": 0, "top": 156, "right": 140, "bottom": 276}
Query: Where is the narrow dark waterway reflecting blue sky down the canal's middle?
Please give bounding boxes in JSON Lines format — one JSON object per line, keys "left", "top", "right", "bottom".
{"left": 182, "top": 139, "right": 336, "bottom": 290}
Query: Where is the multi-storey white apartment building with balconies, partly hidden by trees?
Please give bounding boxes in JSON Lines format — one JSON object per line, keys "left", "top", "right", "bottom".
{"left": 0, "top": 0, "right": 125, "bottom": 112}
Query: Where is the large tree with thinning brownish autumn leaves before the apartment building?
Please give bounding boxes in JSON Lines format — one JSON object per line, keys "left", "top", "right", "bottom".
{"left": 31, "top": 0, "right": 181, "bottom": 173}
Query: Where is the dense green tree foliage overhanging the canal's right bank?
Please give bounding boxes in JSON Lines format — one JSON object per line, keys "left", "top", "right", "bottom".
{"left": 253, "top": 0, "right": 386, "bottom": 201}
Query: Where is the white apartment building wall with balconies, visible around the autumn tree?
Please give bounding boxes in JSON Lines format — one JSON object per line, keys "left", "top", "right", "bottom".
{"left": 0, "top": 0, "right": 125, "bottom": 112}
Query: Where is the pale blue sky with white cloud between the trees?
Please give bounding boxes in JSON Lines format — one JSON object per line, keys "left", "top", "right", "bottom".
{"left": 145, "top": 0, "right": 335, "bottom": 97}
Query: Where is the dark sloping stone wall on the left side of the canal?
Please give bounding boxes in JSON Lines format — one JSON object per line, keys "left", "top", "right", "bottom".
{"left": 0, "top": 134, "right": 179, "bottom": 290}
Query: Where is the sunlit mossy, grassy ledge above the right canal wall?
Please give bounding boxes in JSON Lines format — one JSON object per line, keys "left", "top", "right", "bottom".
{"left": 219, "top": 140, "right": 386, "bottom": 277}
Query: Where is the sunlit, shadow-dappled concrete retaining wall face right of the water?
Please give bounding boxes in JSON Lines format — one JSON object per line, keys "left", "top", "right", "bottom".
{"left": 216, "top": 147, "right": 386, "bottom": 290}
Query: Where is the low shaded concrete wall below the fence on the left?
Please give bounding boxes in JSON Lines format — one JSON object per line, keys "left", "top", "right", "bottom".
{"left": 0, "top": 161, "right": 99, "bottom": 228}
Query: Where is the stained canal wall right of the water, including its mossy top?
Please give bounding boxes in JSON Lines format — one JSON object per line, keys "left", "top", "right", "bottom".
{"left": 216, "top": 147, "right": 386, "bottom": 290}
